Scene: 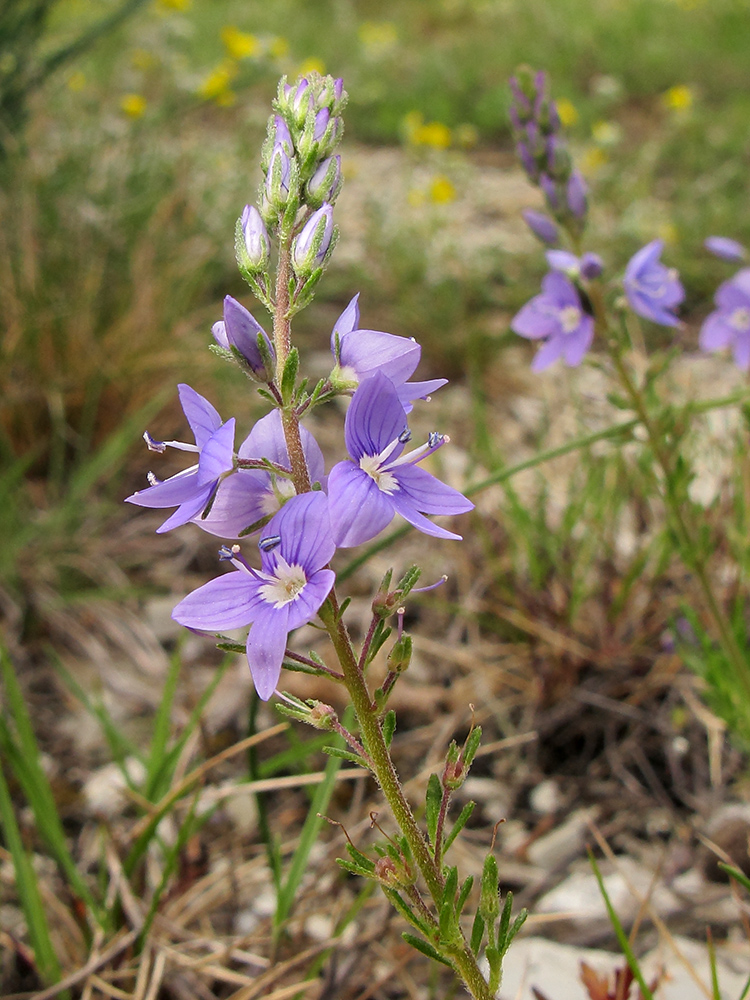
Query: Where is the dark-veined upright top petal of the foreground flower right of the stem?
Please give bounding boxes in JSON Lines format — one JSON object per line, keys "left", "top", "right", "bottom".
{"left": 344, "top": 372, "right": 407, "bottom": 461}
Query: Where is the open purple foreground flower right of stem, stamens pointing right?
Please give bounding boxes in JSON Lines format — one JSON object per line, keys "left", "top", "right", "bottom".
{"left": 328, "top": 372, "right": 474, "bottom": 548}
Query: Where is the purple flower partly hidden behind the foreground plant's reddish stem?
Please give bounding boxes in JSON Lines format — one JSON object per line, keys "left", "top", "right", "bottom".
{"left": 198, "top": 410, "right": 325, "bottom": 538}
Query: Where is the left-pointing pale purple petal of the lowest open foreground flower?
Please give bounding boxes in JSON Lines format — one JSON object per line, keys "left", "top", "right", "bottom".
{"left": 172, "top": 570, "right": 269, "bottom": 632}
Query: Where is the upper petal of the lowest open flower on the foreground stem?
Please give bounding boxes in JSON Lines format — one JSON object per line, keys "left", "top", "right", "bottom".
{"left": 261, "top": 490, "right": 336, "bottom": 578}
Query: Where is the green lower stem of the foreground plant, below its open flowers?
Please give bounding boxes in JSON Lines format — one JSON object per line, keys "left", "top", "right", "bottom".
{"left": 319, "top": 591, "right": 492, "bottom": 1000}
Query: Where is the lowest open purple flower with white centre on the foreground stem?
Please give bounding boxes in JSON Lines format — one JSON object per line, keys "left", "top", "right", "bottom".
{"left": 172, "top": 492, "right": 335, "bottom": 701}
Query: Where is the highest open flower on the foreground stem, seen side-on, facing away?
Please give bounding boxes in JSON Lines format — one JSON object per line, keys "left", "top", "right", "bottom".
{"left": 331, "top": 293, "right": 448, "bottom": 410}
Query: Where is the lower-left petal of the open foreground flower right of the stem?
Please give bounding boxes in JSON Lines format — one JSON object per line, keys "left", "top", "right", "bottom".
{"left": 328, "top": 462, "right": 400, "bottom": 548}
